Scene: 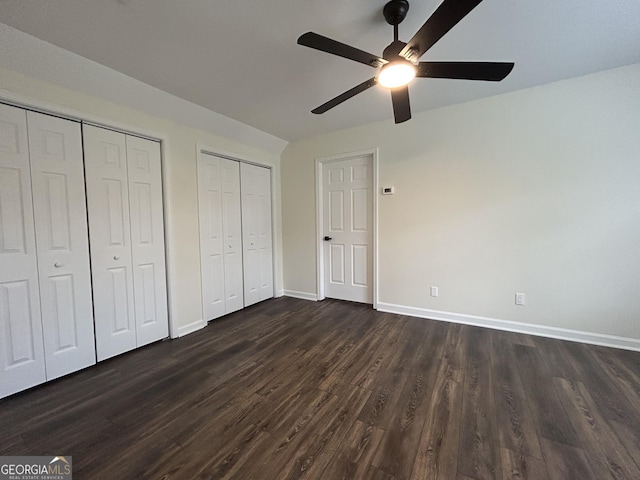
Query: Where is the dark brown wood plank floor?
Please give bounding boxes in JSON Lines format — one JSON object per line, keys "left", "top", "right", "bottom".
{"left": 0, "top": 298, "right": 640, "bottom": 480}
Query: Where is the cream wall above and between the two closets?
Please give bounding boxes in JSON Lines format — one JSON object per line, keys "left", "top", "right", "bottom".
{"left": 0, "top": 24, "right": 286, "bottom": 335}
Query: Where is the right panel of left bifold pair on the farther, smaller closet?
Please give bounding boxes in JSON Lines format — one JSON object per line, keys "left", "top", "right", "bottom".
{"left": 221, "top": 159, "right": 244, "bottom": 313}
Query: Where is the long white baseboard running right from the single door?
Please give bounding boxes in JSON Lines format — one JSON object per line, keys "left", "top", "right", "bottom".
{"left": 378, "top": 302, "right": 640, "bottom": 351}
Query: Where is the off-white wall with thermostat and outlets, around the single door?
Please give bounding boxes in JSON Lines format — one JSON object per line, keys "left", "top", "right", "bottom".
{"left": 281, "top": 64, "right": 640, "bottom": 349}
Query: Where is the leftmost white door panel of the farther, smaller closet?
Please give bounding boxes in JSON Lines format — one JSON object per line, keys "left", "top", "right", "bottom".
{"left": 198, "top": 153, "right": 226, "bottom": 321}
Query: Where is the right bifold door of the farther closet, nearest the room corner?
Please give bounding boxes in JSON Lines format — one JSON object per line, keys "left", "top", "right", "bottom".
{"left": 240, "top": 163, "right": 273, "bottom": 306}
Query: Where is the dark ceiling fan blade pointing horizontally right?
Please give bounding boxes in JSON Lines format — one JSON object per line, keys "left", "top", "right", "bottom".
{"left": 416, "top": 62, "right": 513, "bottom": 82}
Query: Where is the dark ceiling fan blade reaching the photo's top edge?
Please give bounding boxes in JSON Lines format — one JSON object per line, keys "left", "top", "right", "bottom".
{"left": 400, "top": 0, "right": 482, "bottom": 62}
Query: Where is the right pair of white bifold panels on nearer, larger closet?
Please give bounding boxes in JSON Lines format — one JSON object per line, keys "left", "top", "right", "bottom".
{"left": 84, "top": 125, "right": 169, "bottom": 360}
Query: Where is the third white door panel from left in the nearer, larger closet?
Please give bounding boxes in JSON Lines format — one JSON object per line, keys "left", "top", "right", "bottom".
{"left": 83, "top": 125, "right": 136, "bottom": 360}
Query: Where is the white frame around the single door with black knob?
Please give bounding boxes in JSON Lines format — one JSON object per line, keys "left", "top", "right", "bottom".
{"left": 316, "top": 148, "right": 378, "bottom": 310}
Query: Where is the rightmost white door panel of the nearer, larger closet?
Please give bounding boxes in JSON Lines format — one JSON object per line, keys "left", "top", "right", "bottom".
{"left": 126, "top": 135, "right": 169, "bottom": 347}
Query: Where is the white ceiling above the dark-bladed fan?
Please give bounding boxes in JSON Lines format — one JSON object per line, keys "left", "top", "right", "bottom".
{"left": 0, "top": 0, "right": 640, "bottom": 141}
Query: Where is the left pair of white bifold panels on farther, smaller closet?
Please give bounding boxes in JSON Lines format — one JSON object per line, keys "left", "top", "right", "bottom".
{"left": 198, "top": 153, "right": 244, "bottom": 321}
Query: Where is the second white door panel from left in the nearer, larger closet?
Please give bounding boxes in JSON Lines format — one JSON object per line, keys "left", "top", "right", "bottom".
{"left": 27, "top": 112, "right": 96, "bottom": 380}
